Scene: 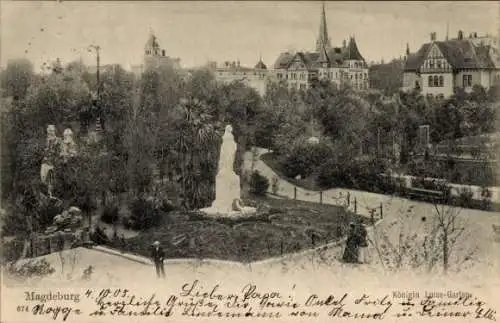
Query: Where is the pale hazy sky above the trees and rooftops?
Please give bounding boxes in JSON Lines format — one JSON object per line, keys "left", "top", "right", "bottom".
{"left": 0, "top": 0, "right": 500, "bottom": 69}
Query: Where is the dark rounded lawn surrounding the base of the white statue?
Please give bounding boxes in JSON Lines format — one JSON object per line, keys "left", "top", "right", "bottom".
{"left": 107, "top": 198, "right": 368, "bottom": 262}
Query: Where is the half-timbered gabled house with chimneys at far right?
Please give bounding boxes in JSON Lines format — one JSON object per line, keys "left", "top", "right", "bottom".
{"left": 402, "top": 31, "right": 500, "bottom": 97}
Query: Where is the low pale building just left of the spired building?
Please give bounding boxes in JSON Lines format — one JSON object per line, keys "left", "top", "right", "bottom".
{"left": 215, "top": 58, "right": 272, "bottom": 95}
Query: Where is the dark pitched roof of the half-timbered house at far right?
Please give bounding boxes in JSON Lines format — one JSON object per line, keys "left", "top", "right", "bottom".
{"left": 405, "top": 39, "right": 495, "bottom": 71}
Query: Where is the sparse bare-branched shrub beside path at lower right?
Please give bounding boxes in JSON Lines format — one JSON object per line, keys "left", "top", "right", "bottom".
{"left": 371, "top": 204, "right": 477, "bottom": 273}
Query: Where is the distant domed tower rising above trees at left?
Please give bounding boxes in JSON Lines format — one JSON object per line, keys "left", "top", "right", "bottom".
{"left": 131, "top": 32, "right": 181, "bottom": 76}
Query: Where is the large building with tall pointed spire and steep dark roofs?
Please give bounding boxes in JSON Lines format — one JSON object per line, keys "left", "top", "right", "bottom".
{"left": 274, "top": 4, "right": 370, "bottom": 90}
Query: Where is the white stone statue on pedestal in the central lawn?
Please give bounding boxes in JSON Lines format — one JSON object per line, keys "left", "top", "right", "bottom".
{"left": 201, "top": 125, "right": 256, "bottom": 217}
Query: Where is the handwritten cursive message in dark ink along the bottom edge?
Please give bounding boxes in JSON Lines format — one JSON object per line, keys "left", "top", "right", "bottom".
{"left": 16, "top": 280, "right": 496, "bottom": 322}
